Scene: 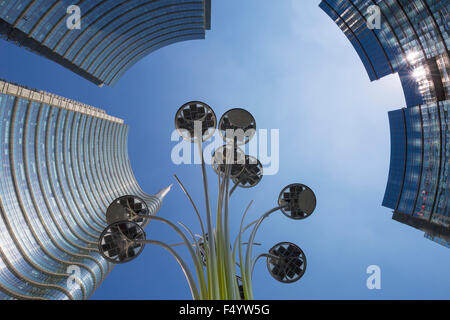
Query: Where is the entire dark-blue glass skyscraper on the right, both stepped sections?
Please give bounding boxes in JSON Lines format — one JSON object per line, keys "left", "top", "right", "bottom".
{"left": 320, "top": 0, "right": 450, "bottom": 247}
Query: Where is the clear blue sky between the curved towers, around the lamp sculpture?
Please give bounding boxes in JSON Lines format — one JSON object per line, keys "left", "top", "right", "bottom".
{"left": 0, "top": 0, "right": 450, "bottom": 299}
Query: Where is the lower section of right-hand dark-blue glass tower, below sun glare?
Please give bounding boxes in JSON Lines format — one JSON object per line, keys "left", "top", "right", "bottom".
{"left": 383, "top": 100, "right": 450, "bottom": 249}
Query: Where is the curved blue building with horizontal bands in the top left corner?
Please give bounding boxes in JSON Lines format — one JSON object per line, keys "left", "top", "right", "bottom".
{"left": 0, "top": 0, "right": 211, "bottom": 86}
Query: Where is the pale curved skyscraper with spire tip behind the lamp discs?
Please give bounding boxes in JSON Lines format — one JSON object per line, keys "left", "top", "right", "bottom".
{"left": 0, "top": 81, "right": 166, "bottom": 299}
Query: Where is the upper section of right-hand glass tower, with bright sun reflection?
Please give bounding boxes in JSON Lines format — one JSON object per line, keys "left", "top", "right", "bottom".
{"left": 320, "top": 0, "right": 450, "bottom": 107}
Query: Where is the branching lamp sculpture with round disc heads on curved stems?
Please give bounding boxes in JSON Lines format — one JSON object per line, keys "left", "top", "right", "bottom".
{"left": 98, "top": 101, "right": 316, "bottom": 300}
